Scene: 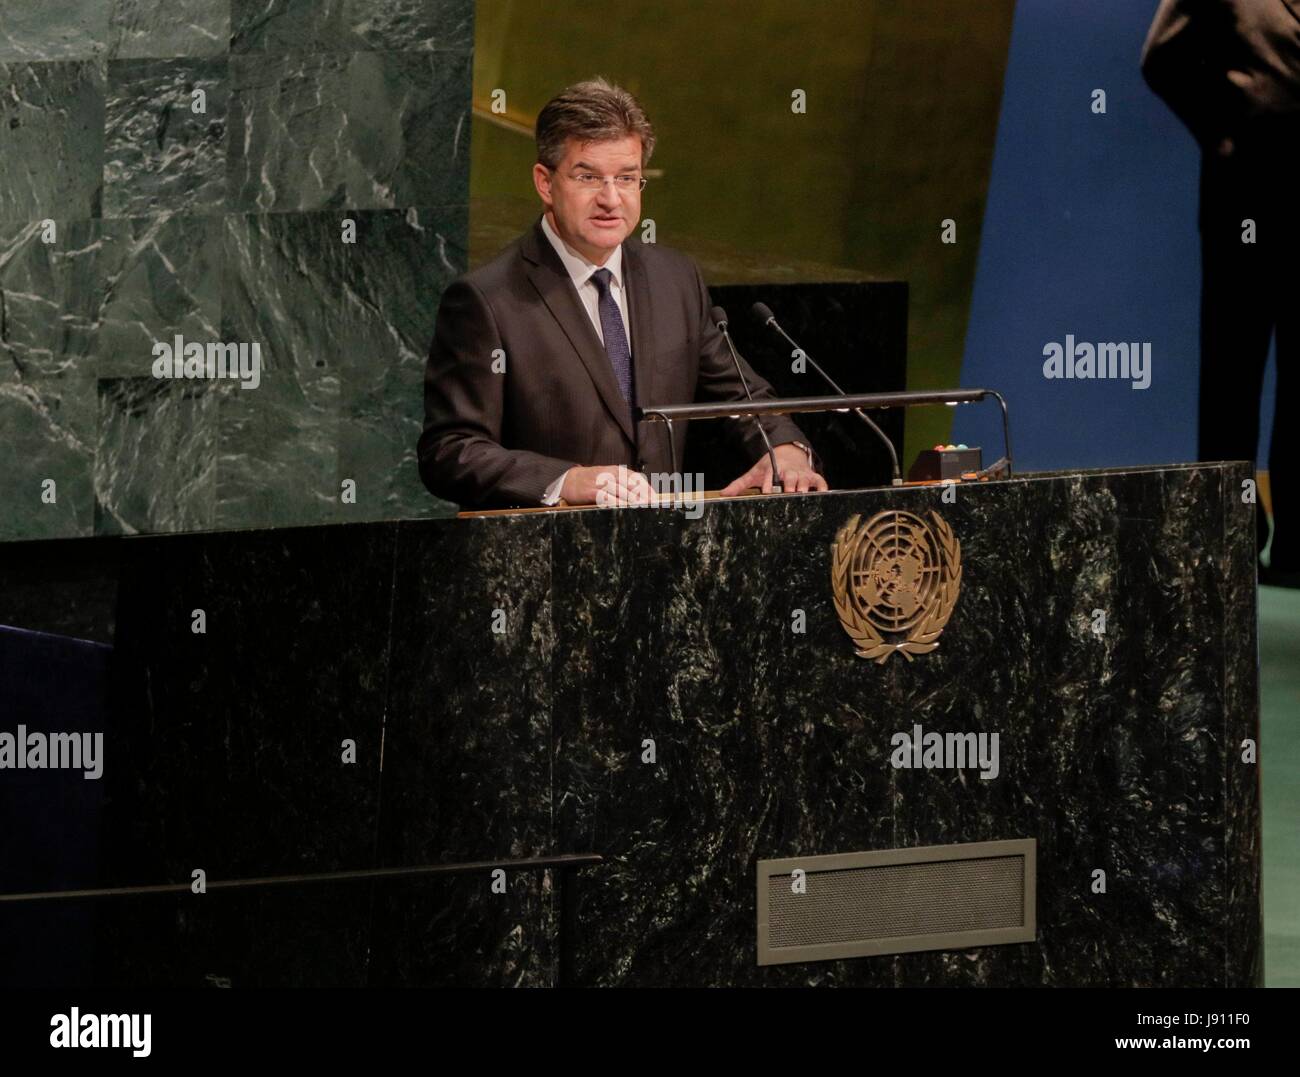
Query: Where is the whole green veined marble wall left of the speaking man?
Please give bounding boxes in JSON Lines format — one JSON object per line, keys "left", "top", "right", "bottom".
{"left": 0, "top": 0, "right": 473, "bottom": 540}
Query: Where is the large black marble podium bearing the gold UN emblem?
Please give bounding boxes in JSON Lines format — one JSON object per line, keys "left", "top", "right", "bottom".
{"left": 0, "top": 463, "right": 1262, "bottom": 987}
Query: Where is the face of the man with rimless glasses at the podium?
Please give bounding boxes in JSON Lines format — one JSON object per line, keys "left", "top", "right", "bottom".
{"left": 533, "top": 135, "right": 641, "bottom": 265}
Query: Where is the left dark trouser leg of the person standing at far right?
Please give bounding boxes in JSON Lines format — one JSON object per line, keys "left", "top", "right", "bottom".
{"left": 1197, "top": 186, "right": 1281, "bottom": 549}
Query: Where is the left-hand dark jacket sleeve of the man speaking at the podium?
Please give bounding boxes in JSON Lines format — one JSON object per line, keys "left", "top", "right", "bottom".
{"left": 417, "top": 280, "right": 575, "bottom": 507}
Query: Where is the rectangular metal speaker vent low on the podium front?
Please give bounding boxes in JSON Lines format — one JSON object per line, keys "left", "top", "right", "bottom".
{"left": 758, "top": 838, "right": 1037, "bottom": 965}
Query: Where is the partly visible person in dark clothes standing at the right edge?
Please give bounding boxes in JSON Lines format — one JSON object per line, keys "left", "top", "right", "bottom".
{"left": 1141, "top": 0, "right": 1300, "bottom": 587}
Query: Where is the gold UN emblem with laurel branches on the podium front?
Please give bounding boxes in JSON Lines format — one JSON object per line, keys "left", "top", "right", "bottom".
{"left": 831, "top": 512, "right": 962, "bottom": 663}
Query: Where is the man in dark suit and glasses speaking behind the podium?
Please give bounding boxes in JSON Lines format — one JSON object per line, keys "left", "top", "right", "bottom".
{"left": 419, "top": 79, "right": 827, "bottom": 507}
